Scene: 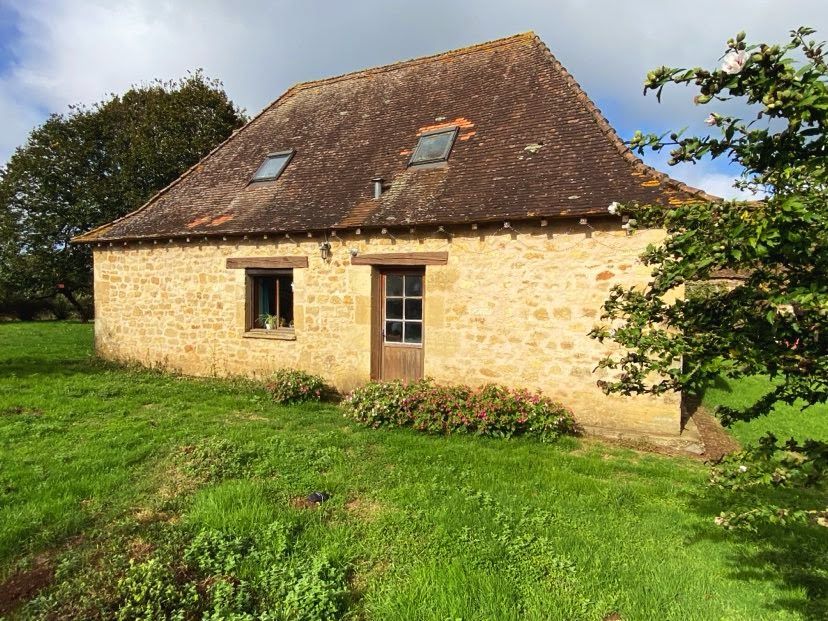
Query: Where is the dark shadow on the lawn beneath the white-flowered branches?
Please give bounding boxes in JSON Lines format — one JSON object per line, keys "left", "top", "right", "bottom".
{"left": 690, "top": 487, "right": 828, "bottom": 621}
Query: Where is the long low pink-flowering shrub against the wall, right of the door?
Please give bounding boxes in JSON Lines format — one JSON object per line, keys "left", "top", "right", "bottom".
{"left": 344, "top": 379, "right": 578, "bottom": 441}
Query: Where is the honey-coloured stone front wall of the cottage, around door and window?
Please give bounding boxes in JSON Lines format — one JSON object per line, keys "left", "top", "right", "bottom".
{"left": 94, "top": 221, "right": 680, "bottom": 435}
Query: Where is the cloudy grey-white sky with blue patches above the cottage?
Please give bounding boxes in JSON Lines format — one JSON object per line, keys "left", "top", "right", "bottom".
{"left": 0, "top": 0, "right": 828, "bottom": 196}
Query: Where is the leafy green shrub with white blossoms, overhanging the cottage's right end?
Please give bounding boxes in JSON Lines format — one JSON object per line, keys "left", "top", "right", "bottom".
{"left": 593, "top": 28, "right": 828, "bottom": 525}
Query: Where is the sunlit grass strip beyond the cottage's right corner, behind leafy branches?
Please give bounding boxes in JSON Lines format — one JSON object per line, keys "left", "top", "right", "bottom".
{"left": 702, "top": 377, "right": 828, "bottom": 444}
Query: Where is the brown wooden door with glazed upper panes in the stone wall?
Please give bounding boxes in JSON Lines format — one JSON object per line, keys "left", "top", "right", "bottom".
{"left": 371, "top": 268, "right": 425, "bottom": 382}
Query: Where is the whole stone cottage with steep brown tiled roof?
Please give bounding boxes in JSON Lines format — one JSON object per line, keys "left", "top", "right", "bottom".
{"left": 75, "top": 33, "right": 704, "bottom": 436}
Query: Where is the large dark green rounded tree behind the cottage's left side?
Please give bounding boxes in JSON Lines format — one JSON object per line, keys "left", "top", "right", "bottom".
{"left": 0, "top": 71, "right": 245, "bottom": 316}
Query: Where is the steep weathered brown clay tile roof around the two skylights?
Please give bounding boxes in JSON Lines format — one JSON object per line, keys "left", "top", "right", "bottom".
{"left": 75, "top": 33, "right": 712, "bottom": 242}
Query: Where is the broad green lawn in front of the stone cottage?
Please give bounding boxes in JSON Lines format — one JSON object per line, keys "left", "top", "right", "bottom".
{"left": 0, "top": 323, "right": 828, "bottom": 621}
